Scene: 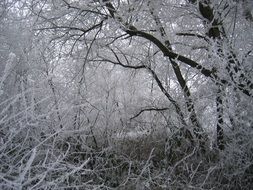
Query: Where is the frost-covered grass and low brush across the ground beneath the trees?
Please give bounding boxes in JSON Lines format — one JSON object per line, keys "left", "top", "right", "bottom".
{"left": 0, "top": 118, "right": 253, "bottom": 189}
